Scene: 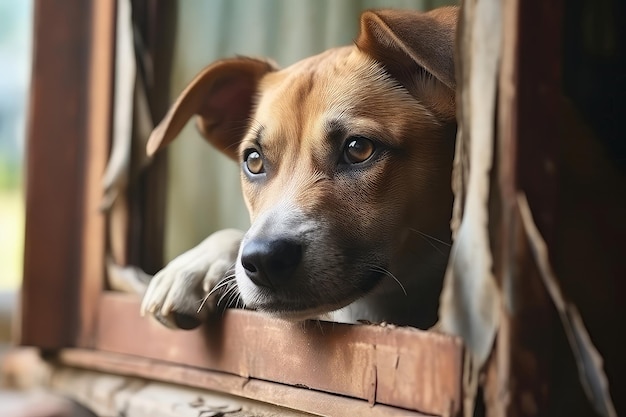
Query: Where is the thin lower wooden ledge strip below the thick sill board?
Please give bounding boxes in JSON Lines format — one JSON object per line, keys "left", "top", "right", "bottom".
{"left": 57, "top": 349, "right": 425, "bottom": 417}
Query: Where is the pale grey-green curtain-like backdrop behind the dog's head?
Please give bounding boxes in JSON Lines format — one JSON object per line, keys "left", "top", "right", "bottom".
{"left": 165, "top": 0, "right": 456, "bottom": 260}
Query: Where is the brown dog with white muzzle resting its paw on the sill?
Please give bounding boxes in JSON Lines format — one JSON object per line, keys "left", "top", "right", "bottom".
{"left": 141, "top": 7, "right": 458, "bottom": 328}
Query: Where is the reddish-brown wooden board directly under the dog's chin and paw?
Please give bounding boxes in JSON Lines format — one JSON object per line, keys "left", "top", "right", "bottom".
{"left": 96, "top": 293, "right": 463, "bottom": 415}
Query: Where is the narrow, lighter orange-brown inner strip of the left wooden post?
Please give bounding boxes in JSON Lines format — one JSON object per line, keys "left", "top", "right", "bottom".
{"left": 77, "top": 1, "right": 116, "bottom": 347}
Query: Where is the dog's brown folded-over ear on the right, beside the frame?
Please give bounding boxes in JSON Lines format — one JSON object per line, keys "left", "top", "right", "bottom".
{"left": 356, "top": 7, "right": 458, "bottom": 119}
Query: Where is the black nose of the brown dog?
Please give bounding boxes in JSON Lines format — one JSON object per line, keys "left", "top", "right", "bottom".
{"left": 241, "top": 239, "right": 302, "bottom": 289}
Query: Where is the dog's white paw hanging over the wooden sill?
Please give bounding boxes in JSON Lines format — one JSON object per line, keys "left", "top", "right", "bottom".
{"left": 141, "top": 229, "right": 243, "bottom": 329}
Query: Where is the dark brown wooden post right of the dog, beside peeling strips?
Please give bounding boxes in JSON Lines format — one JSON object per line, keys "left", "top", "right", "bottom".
{"left": 485, "top": 0, "right": 562, "bottom": 416}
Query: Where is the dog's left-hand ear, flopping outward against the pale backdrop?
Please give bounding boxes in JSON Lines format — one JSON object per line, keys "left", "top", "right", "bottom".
{"left": 146, "top": 57, "right": 276, "bottom": 159}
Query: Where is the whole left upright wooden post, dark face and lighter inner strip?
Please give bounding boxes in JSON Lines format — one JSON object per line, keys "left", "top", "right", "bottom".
{"left": 20, "top": 1, "right": 115, "bottom": 348}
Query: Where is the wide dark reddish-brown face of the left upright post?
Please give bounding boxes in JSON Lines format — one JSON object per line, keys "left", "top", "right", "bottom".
{"left": 20, "top": 0, "right": 92, "bottom": 348}
